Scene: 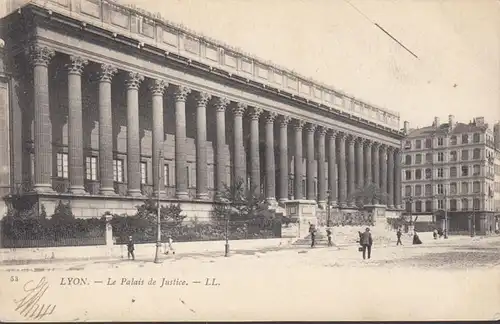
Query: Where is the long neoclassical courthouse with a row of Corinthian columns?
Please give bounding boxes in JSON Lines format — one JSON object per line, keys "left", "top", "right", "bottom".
{"left": 0, "top": 0, "right": 404, "bottom": 217}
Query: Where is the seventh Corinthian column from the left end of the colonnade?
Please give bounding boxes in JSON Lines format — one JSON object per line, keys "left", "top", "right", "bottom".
{"left": 196, "top": 92, "right": 212, "bottom": 200}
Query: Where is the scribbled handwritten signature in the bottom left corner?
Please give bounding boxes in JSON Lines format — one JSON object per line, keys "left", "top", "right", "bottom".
{"left": 14, "top": 277, "right": 56, "bottom": 319}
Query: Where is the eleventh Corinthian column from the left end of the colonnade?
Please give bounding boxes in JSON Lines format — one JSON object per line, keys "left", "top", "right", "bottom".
{"left": 265, "top": 112, "right": 278, "bottom": 206}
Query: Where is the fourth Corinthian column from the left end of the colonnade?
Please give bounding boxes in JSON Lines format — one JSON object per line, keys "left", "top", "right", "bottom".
{"left": 126, "top": 72, "right": 144, "bottom": 197}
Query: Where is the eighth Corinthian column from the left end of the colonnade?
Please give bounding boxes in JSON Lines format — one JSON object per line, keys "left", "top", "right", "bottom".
{"left": 215, "top": 98, "right": 230, "bottom": 196}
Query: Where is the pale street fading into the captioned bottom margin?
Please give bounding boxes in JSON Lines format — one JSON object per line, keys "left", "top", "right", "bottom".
{"left": 0, "top": 237, "right": 500, "bottom": 321}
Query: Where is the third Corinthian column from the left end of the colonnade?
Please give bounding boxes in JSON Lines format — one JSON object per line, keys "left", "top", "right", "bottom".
{"left": 99, "top": 64, "right": 118, "bottom": 196}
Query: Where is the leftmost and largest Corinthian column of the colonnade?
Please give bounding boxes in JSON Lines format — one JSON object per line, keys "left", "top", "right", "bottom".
{"left": 29, "top": 45, "right": 55, "bottom": 193}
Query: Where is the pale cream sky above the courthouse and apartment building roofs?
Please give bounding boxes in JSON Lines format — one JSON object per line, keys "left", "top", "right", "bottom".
{"left": 123, "top": 0, "right": 500, "bottom": 127}
